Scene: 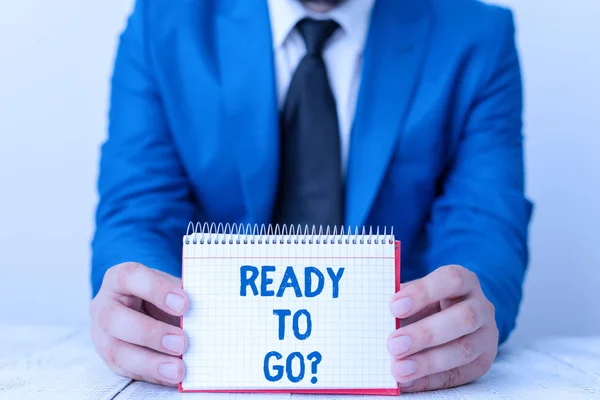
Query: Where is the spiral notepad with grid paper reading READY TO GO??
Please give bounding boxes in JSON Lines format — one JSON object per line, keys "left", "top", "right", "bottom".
{"left": 179, "top": 224, "right": 400, "bottom": 395}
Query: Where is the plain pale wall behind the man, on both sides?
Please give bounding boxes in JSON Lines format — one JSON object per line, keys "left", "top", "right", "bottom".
{"left": 0, "top": 0, "right": 600, "bottom": 341}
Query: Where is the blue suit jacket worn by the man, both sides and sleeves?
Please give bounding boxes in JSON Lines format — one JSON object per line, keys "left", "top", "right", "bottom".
{"left": 91, "top": 0, "right": 532, "bottom": 341}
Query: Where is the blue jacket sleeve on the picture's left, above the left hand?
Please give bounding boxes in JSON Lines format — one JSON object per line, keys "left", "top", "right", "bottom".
{"left": 91, "top": 0, "right": 194, "bottom": 296}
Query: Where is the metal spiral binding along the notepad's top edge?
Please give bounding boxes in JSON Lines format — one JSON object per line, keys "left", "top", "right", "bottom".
{"left": 184, "top": 222, "right": 394, "bottom": 244}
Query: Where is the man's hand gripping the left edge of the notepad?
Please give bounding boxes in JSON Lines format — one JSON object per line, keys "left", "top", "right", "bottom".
{"left": 90, "top": 263, "right": 189, "bottom": 386}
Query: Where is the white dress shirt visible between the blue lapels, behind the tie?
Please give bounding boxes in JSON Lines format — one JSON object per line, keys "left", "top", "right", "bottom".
{"left": 268, "top": 0, "right": 375, "bottom": 173}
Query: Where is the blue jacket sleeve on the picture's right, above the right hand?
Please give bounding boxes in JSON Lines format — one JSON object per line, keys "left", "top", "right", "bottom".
{"left": 427, "top": 9, "right": 533, "bottom": 343}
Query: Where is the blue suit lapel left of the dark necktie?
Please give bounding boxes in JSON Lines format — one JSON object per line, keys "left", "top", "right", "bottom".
{"left": 215, "top": 0, "right": 279, "bottom": 223}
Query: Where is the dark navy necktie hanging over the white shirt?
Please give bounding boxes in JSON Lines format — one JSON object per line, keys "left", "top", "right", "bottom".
{"left": 273, "top": 19, "right": 344, "bottom": 229}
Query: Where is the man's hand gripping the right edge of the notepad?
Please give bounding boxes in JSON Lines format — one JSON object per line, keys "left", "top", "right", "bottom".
{"left": 387, "top": 265, "right": 498, "bottom": 392}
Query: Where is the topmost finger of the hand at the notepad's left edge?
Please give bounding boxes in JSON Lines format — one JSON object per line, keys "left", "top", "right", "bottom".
{"left": 102, "top": 263, "right": 189, "bottom": 316}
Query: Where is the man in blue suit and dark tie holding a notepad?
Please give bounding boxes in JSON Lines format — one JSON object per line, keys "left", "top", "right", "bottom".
{"left": 90, "top": 0, "right": 532, "bottom": 391}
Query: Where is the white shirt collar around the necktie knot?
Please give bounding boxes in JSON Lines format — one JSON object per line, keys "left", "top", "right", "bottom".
{"left": 268, "top": 0, "right": 375, "bottom": 49}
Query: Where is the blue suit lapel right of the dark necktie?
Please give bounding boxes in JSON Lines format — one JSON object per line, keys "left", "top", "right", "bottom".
{"left": 346, "top": 0, "right": 430, "bottom": 226}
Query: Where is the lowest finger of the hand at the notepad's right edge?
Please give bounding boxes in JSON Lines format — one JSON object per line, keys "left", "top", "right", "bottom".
{"left": 400, "top": 352, "right": 495, "bottom": 393}
